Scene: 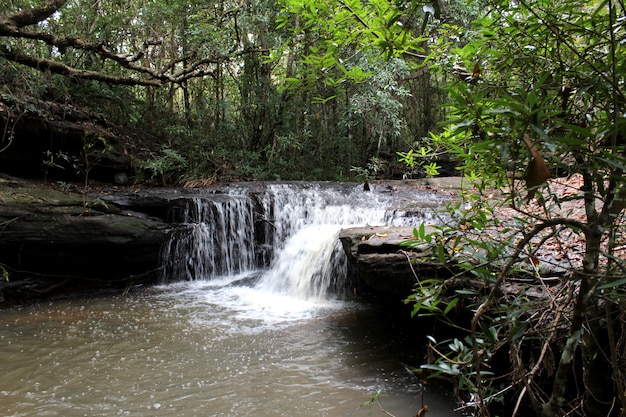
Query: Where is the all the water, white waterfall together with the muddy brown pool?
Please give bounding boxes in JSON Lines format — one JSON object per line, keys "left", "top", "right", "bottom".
{"left": 0, "top": 184, "right": 455, "bottom": 417}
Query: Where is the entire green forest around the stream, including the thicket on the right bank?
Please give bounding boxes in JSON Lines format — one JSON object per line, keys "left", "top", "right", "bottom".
{"left": 0, "top": 0, "right": 626, "bottom": 417}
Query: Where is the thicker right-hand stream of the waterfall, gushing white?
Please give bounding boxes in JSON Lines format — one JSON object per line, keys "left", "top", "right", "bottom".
{"left": 257, "top": 184, "right": 404, "bottom": 302}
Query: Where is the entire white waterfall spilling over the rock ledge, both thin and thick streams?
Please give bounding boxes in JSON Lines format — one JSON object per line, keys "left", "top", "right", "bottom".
{"left": 162, "top": 183, "right": 444, "bottom": 300}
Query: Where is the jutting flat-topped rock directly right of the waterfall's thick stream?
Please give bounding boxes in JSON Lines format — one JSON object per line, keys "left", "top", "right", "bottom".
{"left": 339, "top": 227, "right": 452, "bottom": 298}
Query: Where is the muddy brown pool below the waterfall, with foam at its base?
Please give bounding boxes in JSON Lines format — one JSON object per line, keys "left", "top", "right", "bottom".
{"left": 0, "top": 277, "right": 454, "bottom": 417}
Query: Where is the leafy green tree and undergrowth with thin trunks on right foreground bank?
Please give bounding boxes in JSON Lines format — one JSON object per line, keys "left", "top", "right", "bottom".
{"left": 400, "top": 0, "right": 626, "bottom": 417}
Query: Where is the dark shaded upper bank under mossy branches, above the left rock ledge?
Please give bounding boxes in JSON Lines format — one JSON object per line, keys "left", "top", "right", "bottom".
{"left": 0, "top": 94, "right": 165, "bottom": 183}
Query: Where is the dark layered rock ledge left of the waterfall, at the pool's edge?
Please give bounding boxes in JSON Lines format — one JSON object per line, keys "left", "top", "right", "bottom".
{"left": 0, "top": 179, "right": 173, "bottom": 304}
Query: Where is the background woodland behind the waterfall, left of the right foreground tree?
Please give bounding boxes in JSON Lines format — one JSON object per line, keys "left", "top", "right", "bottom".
{"left": 0, "top": 0, "right": 443, "bottom": 182}
